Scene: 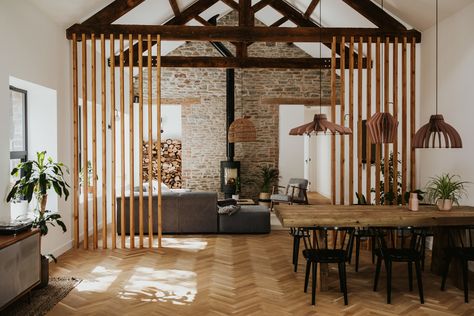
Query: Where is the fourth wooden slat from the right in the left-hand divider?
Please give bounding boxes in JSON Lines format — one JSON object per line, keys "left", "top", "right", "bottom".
{"left": 130, "top": 34, "right": 135, "bottom": 249}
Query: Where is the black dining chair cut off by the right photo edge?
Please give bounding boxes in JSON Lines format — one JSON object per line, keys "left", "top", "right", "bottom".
{"left": 441, "top": 226, "right": 474, "bottom": 303}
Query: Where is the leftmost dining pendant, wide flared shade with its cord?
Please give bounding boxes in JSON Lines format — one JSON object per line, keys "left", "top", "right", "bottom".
{"left": 289, "top": 1, "right": 352, "bottom": 135}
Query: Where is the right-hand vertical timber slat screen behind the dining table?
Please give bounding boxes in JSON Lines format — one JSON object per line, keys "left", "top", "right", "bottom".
{"left": 330, "top": 36, "right": 416, "bottom": 204}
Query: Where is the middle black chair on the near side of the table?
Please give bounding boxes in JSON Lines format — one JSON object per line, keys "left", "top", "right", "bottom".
{"left": 373, "top": 227, "right": 426, "bottom": 304}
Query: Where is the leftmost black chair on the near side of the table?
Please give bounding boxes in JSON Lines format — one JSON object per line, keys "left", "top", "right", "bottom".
{"left": 303, "top": 227, "right": 354, "bottom": 305}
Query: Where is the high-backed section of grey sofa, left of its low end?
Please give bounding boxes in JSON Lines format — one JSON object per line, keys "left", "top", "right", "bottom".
{"left": 117, "top": 192, "right": 218, "bottom": 234}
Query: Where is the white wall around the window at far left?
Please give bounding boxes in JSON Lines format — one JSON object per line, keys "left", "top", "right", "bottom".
{"left": 0, "top": 1, "right": 72, "bottom": 254}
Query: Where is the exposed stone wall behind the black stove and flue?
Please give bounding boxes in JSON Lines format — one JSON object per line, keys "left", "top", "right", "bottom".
{"left": 137, "top": 12, "right": 339, "bottom": 197}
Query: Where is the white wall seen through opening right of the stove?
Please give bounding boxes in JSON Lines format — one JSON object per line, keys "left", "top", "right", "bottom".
{"left": 279, "top": 105, "right": 304, "bottom": 186}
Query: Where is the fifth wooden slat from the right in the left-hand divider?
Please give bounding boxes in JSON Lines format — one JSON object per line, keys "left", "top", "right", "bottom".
{"left": 119, "top": 34, "right": 125, "bottom": 249}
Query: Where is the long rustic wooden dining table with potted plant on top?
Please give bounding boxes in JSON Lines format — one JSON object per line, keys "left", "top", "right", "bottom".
{"left": 274, "top": 205, "right": 474, "bottom": 289}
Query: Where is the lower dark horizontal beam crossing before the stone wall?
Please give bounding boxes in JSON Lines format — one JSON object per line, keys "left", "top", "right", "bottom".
{"left": 115, "top": 56, "right": 367, "bottom": 69}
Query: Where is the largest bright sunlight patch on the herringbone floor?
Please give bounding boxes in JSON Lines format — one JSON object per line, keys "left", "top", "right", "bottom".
{"left": 119, "top": 267, "right": 197, "bottom": 305}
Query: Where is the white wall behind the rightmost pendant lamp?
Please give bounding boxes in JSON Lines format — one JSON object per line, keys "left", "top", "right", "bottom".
{"left": 418, "top": 4, "right": 474, "bottom": 205}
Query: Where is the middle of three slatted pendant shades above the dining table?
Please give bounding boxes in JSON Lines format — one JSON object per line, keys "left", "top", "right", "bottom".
{"left": 367, "top": 112, "right": 398, "bottom": 144}
